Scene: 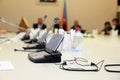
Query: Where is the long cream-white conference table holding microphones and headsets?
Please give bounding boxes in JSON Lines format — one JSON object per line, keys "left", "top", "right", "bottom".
{"left": 0, "top": 35, "right": 120, "bottom": 80}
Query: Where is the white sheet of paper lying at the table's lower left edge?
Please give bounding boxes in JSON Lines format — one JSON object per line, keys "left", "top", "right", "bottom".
{"left": 0, "top": 61, "right": 14, "bottom": 71}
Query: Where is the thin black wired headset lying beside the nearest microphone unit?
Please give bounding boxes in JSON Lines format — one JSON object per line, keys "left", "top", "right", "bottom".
{"left": 56, "top": 58, "right": 104, "bottom": 72}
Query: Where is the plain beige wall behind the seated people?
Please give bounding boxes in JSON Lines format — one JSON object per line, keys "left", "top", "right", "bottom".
{"left": 0, "top": 0, "right": 117, "bottom": 31}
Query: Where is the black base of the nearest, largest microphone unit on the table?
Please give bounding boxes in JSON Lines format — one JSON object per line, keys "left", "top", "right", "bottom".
{"left": 28, "top": 52, "right": 61, "bottom": 63}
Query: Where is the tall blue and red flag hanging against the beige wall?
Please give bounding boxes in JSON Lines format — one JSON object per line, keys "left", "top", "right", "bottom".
{"left": 62, "top": 0, "right": 68, "bottom": 31}
